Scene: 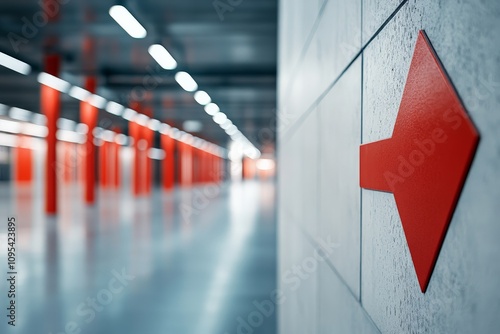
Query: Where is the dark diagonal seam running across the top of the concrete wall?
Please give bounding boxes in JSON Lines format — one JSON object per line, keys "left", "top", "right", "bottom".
{"left": 280, "top": 0, "right": 408, "bottom": 142}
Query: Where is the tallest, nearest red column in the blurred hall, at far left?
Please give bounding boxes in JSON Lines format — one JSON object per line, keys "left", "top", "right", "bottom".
{"left": 40, "top": 55, "right": 61, "bottom": 214}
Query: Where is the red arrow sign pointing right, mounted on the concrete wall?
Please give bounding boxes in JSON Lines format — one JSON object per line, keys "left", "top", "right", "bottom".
{"left": 360, "top": 31, "right": 479, "bottom": 292}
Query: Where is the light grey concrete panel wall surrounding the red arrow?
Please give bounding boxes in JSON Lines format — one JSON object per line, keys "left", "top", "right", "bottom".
{"left": 277, "top": 0, "right": 500, "bottom": 334}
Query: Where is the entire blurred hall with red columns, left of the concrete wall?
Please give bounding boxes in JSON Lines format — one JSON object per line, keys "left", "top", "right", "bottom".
{"left": 0, "top": 0, "right": 277, "bottom": 334}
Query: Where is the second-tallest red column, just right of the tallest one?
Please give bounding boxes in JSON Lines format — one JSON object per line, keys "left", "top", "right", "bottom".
{"left": 80, "top": 77, "right": 98, "bottom": 204}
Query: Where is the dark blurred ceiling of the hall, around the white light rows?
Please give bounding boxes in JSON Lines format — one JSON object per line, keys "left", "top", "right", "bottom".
{"left": 0, "top": 0, "right": 277, "bottom": 148}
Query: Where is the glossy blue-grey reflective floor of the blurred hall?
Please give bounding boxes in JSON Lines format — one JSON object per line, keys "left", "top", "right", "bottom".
{"left": 0, "top": 182, "right": 276, "bottom": 334}
